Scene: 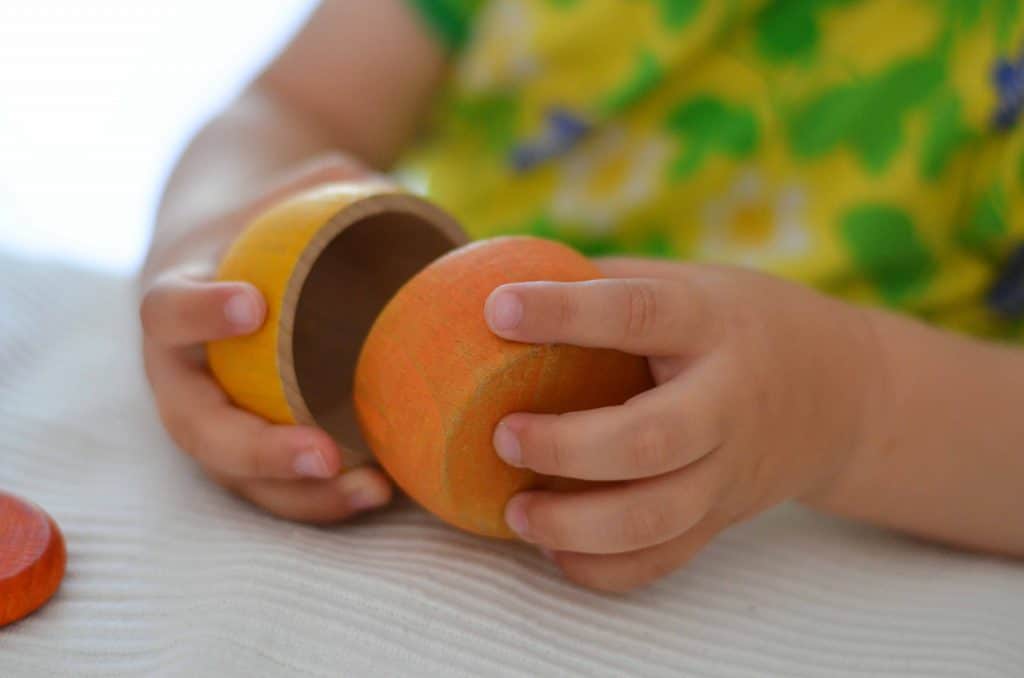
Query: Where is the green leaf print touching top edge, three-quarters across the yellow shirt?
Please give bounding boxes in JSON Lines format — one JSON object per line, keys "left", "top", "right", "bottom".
{"left": 756, "top": 0, "right": 852, "bottom": 61}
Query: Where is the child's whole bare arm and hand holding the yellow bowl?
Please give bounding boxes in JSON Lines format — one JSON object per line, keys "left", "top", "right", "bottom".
{"left": 140, "top": 0, "right": 443, "bottom": 522}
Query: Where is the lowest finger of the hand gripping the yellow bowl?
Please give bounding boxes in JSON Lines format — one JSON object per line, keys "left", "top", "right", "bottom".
{"left": 224, "top": 466, "right": 392, "bottom": 524}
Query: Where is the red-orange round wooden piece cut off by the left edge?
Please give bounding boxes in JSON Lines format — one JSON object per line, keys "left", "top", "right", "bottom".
{"left": 0, "top": 493, "right": 67, "bottom": 626}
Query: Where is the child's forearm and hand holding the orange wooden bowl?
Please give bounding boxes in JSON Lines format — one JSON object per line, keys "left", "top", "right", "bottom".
{"left": 484, "top": 260, "right": 1024, "bottom": 590}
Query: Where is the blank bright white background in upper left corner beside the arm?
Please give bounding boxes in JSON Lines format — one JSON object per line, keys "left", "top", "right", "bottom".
{"left": 0, "top": 0, "right": 312, "bottom": 279}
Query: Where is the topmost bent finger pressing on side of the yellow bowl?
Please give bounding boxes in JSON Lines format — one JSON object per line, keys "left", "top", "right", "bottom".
{"left": 139, "top": 274, "right": 266, "bottom": 347}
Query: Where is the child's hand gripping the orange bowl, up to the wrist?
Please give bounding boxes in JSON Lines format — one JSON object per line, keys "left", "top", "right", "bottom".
{"left": 485, "top": 259, "right": 880, "bottom": 591}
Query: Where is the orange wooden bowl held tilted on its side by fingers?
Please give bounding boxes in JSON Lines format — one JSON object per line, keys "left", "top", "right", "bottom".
{"left": 354, "top": 238, "right": 651, "bottom": 538}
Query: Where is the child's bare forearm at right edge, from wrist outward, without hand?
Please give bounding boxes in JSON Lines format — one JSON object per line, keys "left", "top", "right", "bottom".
{"left": 807, "top": 310, "right": 1024, "bottom": 556}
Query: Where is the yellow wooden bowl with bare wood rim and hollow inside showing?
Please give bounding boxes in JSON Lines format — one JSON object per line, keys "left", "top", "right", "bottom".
{"left": 207, "top": 181, "right": 468, "bottom": 467}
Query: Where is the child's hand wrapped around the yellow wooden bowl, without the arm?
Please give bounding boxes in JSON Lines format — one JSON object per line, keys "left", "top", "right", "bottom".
{"left": 140, "top": 160, "right": 391, "bottom": 522}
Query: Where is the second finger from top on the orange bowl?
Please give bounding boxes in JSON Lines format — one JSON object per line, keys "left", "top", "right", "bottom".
{"left": 494, "top": 367, "right": 723, "bottom": 480}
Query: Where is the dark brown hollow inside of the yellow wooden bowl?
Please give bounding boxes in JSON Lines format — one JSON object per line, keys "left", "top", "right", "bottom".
{"left": 286, "top": 198, "right": 466, "bottom": 466}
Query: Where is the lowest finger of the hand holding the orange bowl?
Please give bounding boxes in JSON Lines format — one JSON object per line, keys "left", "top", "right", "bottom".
{"left": 550, "top": 517, "right": 725, "bottom": 593}
